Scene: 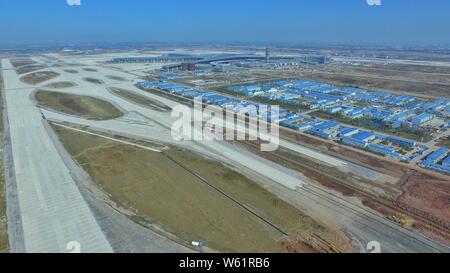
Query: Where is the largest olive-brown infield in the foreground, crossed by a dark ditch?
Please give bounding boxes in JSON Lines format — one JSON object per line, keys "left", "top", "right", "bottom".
{"left": 51, "top": 124, "right": 348, "bottom": 252}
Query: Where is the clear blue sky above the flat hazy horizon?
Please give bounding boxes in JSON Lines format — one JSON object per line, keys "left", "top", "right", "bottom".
{"left": 0, "top": 0, "right": 450, "bottom": 45}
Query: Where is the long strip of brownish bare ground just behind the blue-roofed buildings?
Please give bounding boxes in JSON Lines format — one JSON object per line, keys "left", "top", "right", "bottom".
{"left": 208, "top": 61, "right": 450, "bottom": 98}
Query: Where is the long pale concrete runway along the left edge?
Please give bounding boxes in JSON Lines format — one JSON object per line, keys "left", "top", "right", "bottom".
{"left": 2, "top": 60, "right": 116, "bottom": 253}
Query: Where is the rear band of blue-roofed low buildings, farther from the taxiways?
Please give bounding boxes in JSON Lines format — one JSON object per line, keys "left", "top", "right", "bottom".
{"left": 229, "top": 80, "right": 450, "bottom": 129}
